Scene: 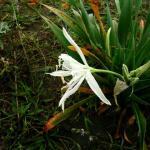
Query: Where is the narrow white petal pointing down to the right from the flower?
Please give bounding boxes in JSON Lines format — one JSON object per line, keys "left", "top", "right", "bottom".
{"left": 86, "top": 71, "right": 111, "bottom": 105}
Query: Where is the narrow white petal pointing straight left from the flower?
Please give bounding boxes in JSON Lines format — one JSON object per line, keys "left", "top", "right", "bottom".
{"left": 46, "top": 70, "right": 71, "bottom": 77}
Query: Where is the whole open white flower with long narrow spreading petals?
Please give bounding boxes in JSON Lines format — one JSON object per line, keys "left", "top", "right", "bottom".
{"left": 48, "top": 29, "right": 111, "bottom": 110}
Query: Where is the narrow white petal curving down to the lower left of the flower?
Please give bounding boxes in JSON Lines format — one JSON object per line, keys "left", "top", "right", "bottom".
{"left": 59, "top": 76, "right": 85, "bottom": 109}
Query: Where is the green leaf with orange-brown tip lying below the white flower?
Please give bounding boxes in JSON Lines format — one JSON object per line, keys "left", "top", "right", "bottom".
{"left": 43, "top": 95, "right": 95, "bottom": 132}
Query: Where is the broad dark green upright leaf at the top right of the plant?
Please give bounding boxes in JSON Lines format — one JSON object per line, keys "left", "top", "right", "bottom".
{"left": 118, "top": 0, "right": 132, "bottom": 47}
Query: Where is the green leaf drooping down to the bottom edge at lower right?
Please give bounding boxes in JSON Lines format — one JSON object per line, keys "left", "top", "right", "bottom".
{"left": 130, "top": 102, "right": 147, "bottom": 150}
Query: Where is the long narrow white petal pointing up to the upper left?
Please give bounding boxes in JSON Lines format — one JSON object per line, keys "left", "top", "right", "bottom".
{"left": 63, "top": 28, "right": 88, "bottom": 66}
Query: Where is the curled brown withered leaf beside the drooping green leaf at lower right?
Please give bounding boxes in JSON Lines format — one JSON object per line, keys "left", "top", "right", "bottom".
{"left": 124, "top": 115, "right": 136, "bottom": 145}
